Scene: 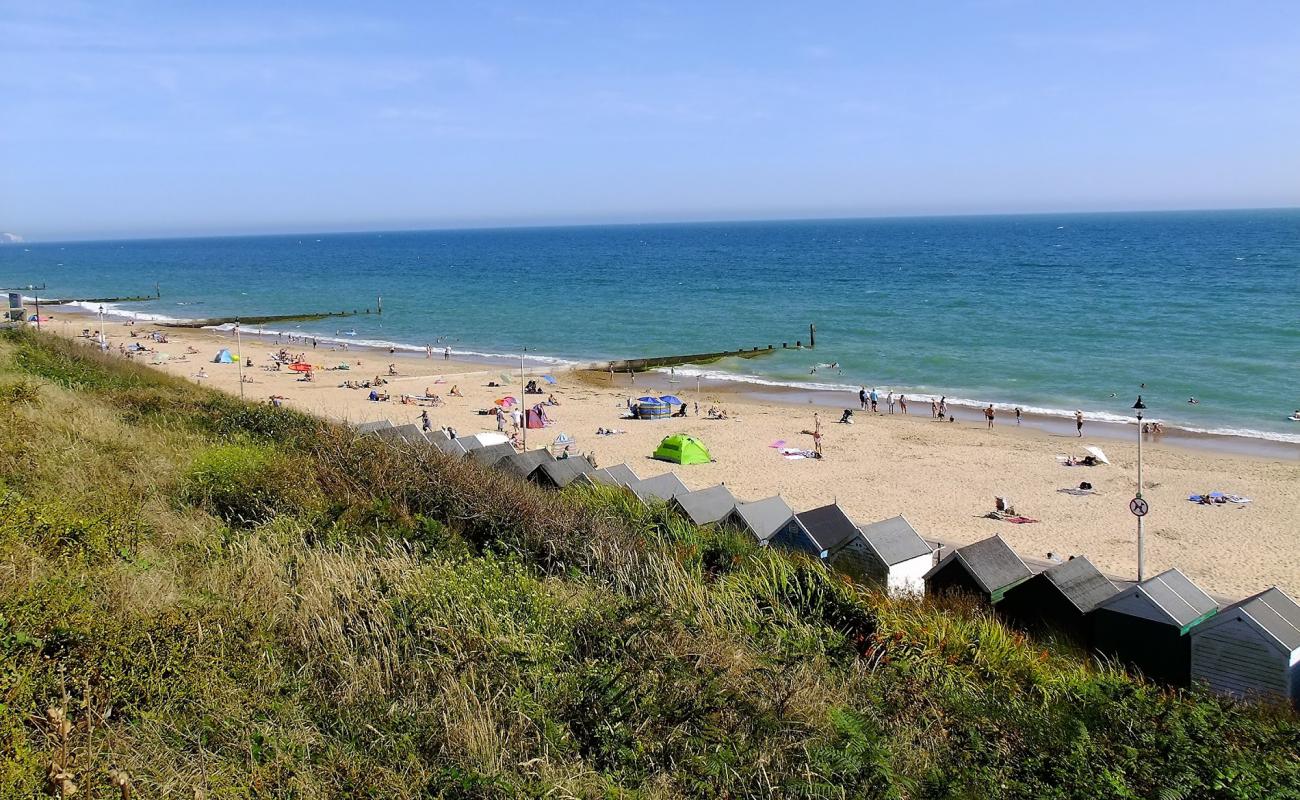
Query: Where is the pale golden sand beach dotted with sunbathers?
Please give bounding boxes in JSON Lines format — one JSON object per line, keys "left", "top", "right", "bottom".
{"left": 48, "top": 313, "right": 1300, "bottom": 597}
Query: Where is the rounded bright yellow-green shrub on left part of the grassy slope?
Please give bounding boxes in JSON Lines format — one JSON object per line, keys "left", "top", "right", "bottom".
{"left": 181, "top": 445, "right": 322, "bottom": 527}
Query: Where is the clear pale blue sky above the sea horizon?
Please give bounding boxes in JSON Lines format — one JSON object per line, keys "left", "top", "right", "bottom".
{"left": 0, "top": 0, "right": 1300, "bottom": 239}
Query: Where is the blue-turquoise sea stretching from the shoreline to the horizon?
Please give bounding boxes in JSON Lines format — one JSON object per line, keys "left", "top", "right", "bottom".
{"left": 0, "top": 209, "right": 1300, "bottom": 442}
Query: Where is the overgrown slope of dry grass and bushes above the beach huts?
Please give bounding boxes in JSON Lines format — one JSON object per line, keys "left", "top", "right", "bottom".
{"left": 0, "top": 334, "right": 1300, "bottom": 797}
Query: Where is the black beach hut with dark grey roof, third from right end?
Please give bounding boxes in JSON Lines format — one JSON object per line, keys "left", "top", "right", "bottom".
{"left": 997, "top": 555, "right": 1119, "bottom": 644}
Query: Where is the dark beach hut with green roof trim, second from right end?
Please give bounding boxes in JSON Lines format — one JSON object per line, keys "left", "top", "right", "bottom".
{"left": 1088, "top": 570, "right": 1218, "bottom": 686}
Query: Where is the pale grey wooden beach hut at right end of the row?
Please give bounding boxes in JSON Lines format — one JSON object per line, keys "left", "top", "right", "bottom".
{"left": 1190, "top": 587, "right": 1300, "bottom": 706}
